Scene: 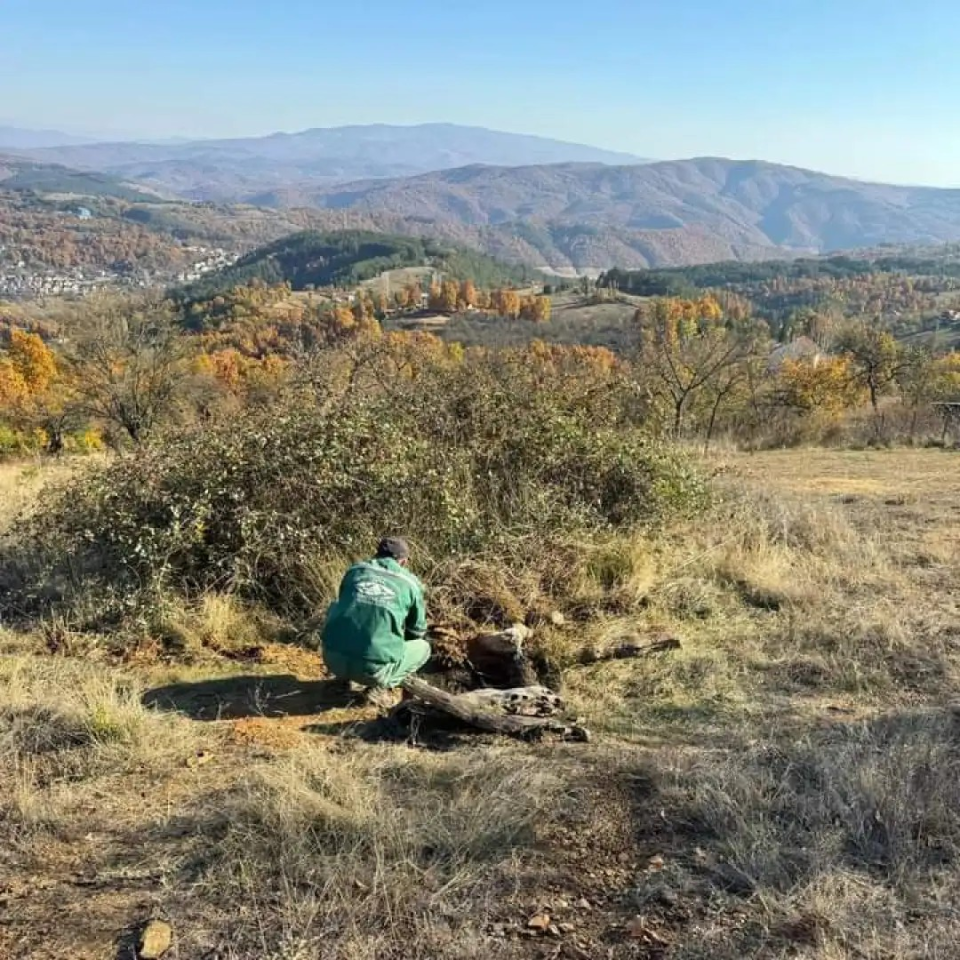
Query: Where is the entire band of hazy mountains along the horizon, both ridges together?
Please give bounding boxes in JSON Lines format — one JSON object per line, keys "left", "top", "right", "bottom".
{"left": 9, "top": 124, "right": 960, "bottom": 273}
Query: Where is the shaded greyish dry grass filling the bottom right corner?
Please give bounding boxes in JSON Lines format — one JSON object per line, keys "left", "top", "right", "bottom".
{"left": 634, "top": 711, "right": 960, "bottom": 960}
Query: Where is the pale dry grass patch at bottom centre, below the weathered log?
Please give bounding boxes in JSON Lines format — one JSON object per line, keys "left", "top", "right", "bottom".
{"left": 201, "top": 747, "right": 562, "bottom": 960}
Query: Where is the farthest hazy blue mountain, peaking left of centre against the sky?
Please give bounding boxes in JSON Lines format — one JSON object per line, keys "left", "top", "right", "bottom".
{"left": 13, "top": 123, "right": 642, "bottom": 203}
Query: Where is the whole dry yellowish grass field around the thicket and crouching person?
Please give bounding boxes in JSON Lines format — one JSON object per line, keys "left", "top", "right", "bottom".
{"left": 0, "top": 450, "right": 960, "bottom": 960}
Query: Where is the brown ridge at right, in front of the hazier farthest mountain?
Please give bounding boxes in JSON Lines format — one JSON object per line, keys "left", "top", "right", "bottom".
{"left": 294, "top": 158, "right": 960, "bottom": 270}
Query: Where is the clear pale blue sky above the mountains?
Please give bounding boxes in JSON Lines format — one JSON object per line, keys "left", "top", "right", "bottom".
{"left": 0, "top": 0, "right": 960, "bottom": 187}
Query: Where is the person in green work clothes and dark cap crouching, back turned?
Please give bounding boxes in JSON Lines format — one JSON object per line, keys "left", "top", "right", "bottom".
{"left": 322, "top": 537, "right": 430, "bottom": 705}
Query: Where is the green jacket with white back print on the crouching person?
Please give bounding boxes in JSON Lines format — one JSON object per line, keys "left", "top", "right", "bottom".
{"left": 323, "top": 558, "right": 427, "bottom": 670}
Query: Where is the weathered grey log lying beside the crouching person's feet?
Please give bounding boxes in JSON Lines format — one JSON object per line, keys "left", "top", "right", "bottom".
{"left": 402, "top": 676, "right": 590, "bottom": 742}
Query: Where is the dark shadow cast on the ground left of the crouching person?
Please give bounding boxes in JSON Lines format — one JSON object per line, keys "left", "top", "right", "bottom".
{"left": 143, "top": 675, "right": 356, "bottom": 720}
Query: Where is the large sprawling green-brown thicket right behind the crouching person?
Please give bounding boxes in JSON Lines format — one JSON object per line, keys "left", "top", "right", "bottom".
{"left": 2, "top": 343, "right": 705, "bottom": 630}
